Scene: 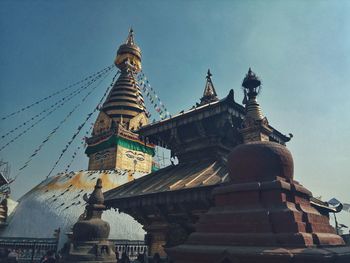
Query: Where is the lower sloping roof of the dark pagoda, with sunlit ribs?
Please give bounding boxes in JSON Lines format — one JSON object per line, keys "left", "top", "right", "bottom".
{"left": 104, "top": 159, "right": 228, "bottom": 206}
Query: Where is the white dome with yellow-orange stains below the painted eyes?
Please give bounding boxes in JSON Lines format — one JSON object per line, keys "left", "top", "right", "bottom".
{"left": 0, "top": 169, "right": 145, "bottom": 250}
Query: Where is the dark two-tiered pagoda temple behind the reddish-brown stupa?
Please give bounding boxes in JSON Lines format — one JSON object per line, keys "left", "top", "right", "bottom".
{"left": 105, "top": 67, "right": 290, "bottom": 256}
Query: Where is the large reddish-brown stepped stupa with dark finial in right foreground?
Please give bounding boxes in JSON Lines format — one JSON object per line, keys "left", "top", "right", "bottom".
{"left": 166, "top": 70, "right": 350, "bottom": 263}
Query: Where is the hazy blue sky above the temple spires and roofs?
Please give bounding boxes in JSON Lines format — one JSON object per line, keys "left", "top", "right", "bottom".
{"left": 0, "top": 0, "right": 350, "bottom": 229}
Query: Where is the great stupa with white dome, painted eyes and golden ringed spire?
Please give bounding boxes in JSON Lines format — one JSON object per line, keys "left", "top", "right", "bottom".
{"left": 0, "top": 30, "right": 155, "bottom": 251}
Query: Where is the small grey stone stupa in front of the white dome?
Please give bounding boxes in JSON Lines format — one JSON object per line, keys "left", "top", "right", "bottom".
{"left": 63, "top": 179, "right": 116, "bottom": 263}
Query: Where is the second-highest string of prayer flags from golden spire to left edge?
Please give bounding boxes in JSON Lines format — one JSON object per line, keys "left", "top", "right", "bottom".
{"left": 1, "top": 71, "right": 112, "bottom": 139}
